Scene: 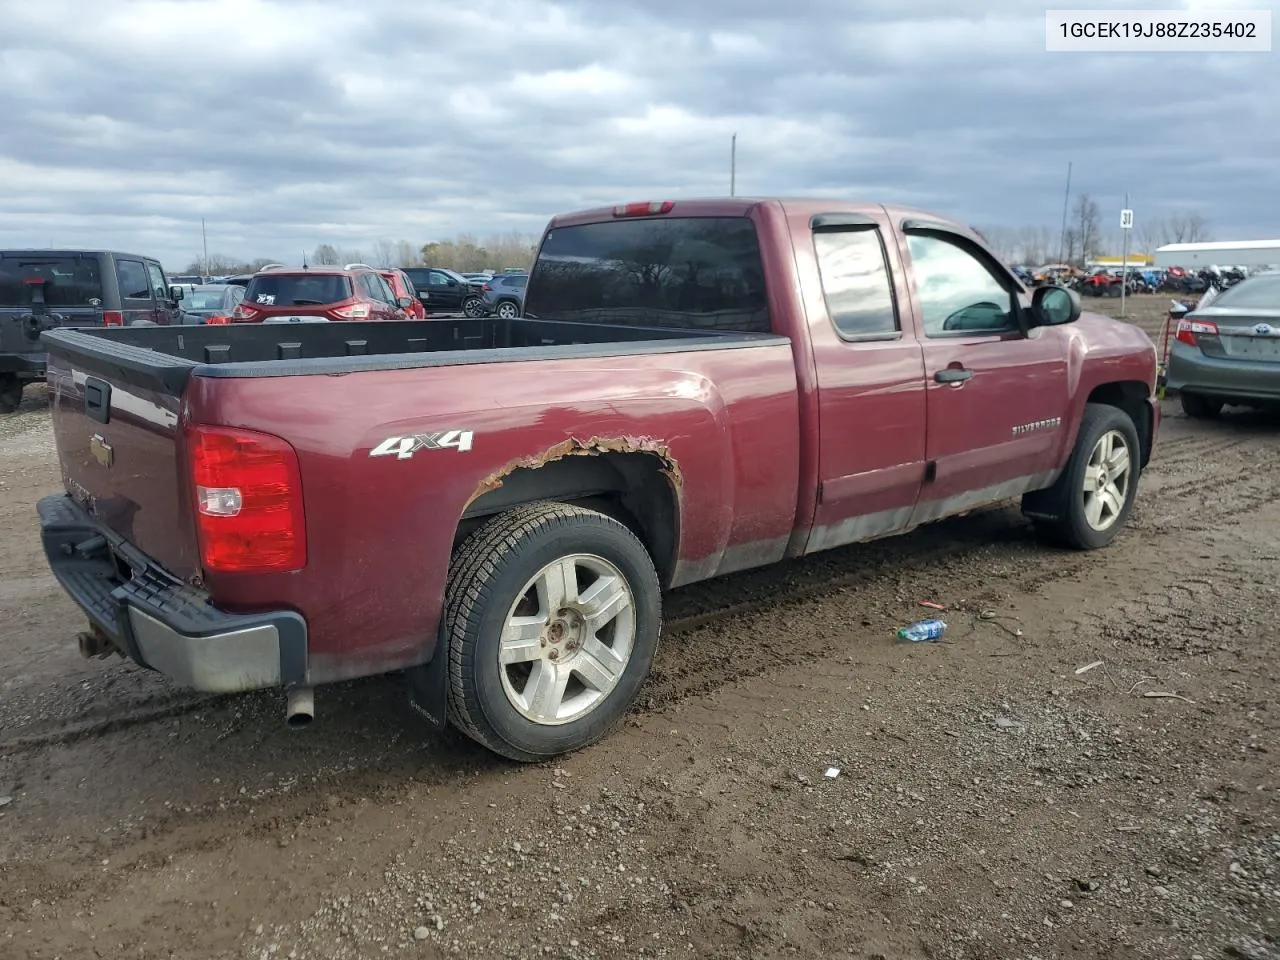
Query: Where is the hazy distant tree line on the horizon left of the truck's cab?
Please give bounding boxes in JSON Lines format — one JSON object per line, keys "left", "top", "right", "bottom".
{"left": 184, "top": 233, "right": 538, "bottom": 276}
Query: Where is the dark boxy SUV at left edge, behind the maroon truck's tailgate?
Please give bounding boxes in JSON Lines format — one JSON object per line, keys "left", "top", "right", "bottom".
{"left": 0, "top": 250, "right": 182, "bottom": 413}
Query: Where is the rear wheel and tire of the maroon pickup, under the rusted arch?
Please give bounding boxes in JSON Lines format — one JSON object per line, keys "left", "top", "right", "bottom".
{"left": 444, "top": 502, "right": 662, "bottom": 763}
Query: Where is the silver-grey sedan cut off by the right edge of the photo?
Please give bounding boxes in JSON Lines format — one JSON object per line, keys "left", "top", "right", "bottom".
{"left": 1167, "top": 274, "right": 1280, "bottom": 419}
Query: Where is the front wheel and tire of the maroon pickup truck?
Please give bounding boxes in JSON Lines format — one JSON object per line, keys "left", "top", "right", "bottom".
{"left": 1023, "top": 403, "right": 1142, "bottom": 550}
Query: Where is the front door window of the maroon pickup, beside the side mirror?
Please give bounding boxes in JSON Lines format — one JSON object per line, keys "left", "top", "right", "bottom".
{"left": 906, "top": 234, "right": 1018, "bottom": 337}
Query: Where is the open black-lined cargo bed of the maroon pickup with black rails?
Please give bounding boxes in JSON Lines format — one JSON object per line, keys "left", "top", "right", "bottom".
{"left": 45, "top": 317, "right": 785, "bottom": 394}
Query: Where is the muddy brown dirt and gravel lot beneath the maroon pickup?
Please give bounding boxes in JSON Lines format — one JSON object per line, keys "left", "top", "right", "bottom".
{"left": 0, "top": 297, "right": 1280, "bottom": 960}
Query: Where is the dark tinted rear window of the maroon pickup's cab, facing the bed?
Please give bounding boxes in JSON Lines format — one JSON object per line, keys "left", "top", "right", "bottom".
{"left": 525, "top": 218, "right": 769, "bottom": 333}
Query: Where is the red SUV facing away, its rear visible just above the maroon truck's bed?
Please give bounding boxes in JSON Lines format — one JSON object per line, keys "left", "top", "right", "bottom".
{"left": 232, "top": 264, "right": 412, "bottom": 324}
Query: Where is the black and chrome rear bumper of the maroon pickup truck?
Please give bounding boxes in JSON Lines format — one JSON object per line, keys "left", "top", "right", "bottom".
{"left": 37, "top": 494, "right": 307, "bottom": 694}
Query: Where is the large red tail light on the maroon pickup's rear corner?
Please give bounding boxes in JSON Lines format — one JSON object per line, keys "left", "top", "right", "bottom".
{"left": 186, "top": 424, "right": 307, "bottom": 573}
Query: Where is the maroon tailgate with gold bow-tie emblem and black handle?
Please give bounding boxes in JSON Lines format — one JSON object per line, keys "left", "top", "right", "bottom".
{"left": 49, "top": 343, "right": 200, "bottom": 580}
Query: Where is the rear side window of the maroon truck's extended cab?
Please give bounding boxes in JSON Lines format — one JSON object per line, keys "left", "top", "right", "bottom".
{"left": 813, "top": 229, "right": 897, "bottom": 337}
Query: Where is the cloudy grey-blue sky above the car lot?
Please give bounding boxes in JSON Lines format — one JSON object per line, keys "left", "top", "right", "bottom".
{"left": 0, "top": 0, "right": 1280, "bottom": 269}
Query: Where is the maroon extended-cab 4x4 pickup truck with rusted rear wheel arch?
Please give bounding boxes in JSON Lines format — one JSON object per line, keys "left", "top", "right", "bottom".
{"left": 40, "top": 198, "right": 1158, "bottom": 762}
